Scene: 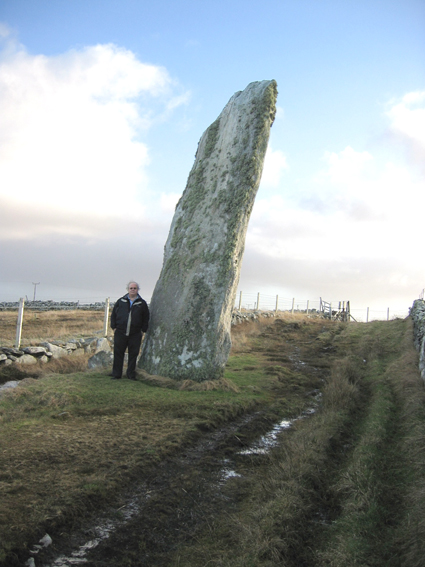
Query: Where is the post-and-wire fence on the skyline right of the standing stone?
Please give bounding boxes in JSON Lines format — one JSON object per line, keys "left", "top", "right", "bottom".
{"left": 235, "top": 291, "right": 413, "bottom": 323}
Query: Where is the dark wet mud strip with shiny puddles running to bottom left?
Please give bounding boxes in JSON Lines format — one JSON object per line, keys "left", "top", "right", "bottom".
{"left": 22, "top": 318, "right": 332, "bottom": 567}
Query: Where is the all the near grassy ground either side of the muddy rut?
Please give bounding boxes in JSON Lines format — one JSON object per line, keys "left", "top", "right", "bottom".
{"left": 0, "top": 314, "right": 425, "bottom": 567}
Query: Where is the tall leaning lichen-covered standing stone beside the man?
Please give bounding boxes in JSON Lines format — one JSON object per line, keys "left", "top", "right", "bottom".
{"left": 139, "top": 81, "right": 277, "bottom": 382}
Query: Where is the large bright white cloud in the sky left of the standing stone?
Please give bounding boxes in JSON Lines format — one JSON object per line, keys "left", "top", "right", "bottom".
{"left": 0, "top": 30, "right": 187, "bottom": 220}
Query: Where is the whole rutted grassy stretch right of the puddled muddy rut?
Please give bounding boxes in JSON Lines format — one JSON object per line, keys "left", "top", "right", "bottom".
{"left": 168, "top": 320, "right": 425, "bottom": 567}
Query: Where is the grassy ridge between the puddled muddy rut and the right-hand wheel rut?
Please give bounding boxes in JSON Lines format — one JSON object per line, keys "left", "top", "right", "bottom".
{"left": 173, "top": 342, "right": 359, "bottom": 567}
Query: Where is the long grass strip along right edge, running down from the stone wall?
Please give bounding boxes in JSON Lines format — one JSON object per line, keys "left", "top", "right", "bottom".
{"left": 318, "top": 321, "right": 425, "bottom": 567}
